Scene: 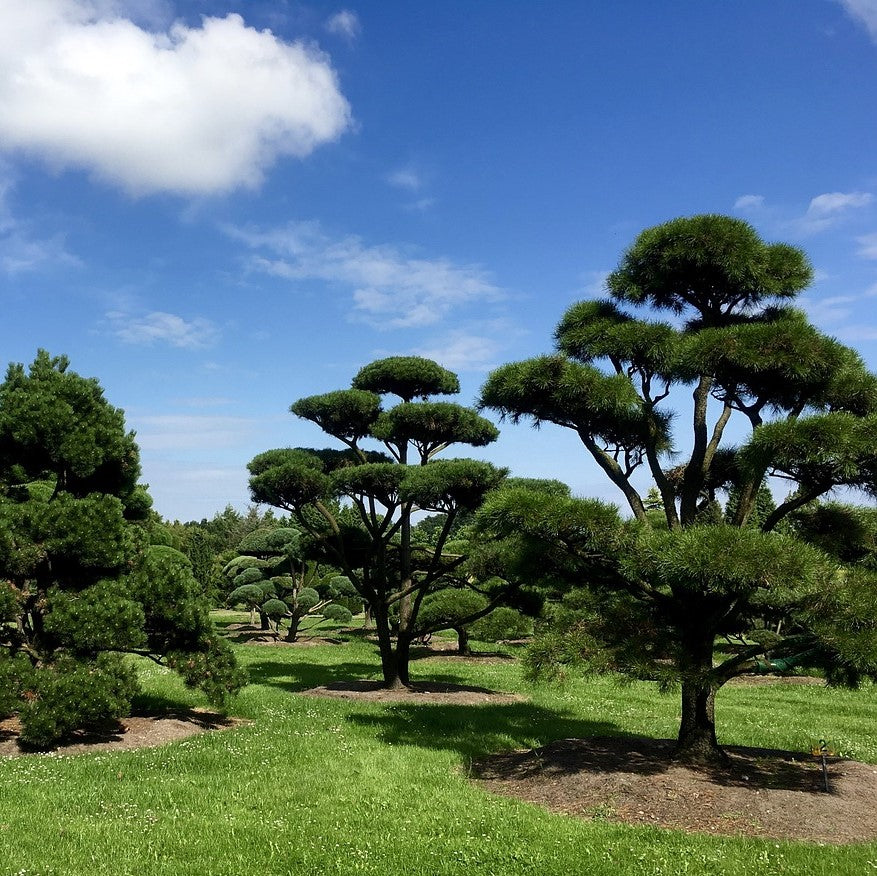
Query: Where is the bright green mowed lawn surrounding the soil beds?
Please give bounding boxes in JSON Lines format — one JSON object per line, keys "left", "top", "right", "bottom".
{"left": 0, "top": 631, "right": 877, "bottom": 876}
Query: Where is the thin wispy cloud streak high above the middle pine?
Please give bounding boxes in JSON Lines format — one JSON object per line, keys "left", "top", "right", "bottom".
{"left": 227, "top": 222, "right": 503, "bottom": 328}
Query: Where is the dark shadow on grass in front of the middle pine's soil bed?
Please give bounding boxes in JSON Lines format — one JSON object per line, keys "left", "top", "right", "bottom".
{"left": 347, "top": 702, "right": 621, "bottom": 762}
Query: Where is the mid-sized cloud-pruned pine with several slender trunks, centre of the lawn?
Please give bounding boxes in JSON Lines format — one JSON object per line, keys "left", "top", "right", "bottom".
{"left": 249, "top": 356, "right": 504, "bottom": 687}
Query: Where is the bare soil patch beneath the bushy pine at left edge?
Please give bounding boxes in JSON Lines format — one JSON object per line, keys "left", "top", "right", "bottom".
{"left": 0, "top": 709, "right": 247, "bottom": 757}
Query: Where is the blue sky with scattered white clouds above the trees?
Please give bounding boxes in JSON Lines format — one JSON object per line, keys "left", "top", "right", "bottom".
{"left": 0, "top": 0, "right": 877, "bottom": 520}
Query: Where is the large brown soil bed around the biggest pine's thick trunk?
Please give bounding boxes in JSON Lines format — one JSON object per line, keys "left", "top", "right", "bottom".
{"left": 471, "top": 737, "right": 877, "bottom": 844}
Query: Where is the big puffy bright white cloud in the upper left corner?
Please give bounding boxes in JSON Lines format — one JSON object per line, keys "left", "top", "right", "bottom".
{"left": 0, "top": 0, "right": 350, "bottom": 194}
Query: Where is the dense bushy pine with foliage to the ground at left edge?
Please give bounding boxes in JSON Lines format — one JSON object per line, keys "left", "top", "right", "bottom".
{"left": 0, "top": 351, "right": 244, "bottom": 747}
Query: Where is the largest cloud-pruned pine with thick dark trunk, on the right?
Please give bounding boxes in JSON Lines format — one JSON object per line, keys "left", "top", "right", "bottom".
{"left": 481, "top": 215, "right": 877, "bottom": 760}
